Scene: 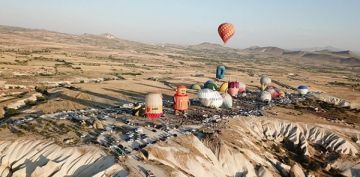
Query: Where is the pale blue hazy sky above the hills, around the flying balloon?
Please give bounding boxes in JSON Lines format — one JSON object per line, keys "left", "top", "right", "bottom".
{"left": 0, "top": 0, "right": 360, "bottom": 51}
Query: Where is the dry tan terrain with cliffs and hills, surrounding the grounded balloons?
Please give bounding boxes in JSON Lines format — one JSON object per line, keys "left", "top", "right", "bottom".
{"left": 0, "top": 26, "right": 360, "bottom": 176}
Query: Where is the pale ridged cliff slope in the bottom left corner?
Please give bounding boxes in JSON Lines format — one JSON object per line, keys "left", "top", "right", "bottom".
{"left": 0, "top": 140, "right": 127, "bottom": 177}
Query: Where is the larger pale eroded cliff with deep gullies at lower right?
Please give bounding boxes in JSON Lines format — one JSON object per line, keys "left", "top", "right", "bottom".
{"left": 144, "top": 118, "right": 360, "bottom": 177}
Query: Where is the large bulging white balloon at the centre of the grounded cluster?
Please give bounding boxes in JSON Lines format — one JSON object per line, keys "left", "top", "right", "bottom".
{"left": 197, "top": 89, "right": 223, "bottom": 108}
